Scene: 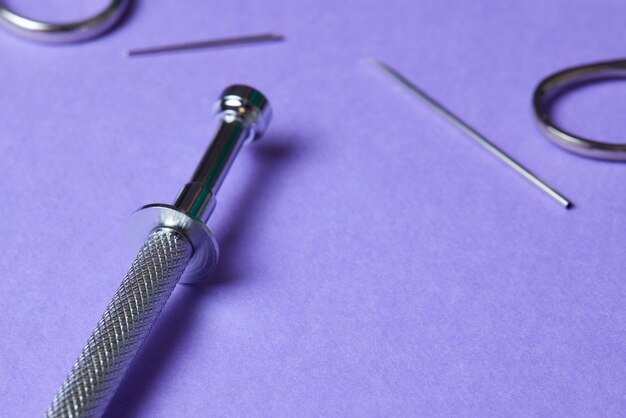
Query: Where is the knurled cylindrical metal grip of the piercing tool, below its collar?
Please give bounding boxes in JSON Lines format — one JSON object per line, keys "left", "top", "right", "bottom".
{"left": 46, "top": 228, "right": 191, "bottom": 417}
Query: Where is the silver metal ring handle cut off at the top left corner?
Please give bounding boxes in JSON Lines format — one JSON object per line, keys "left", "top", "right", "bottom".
{"left": 0, "top": 0, "right": 131, "bottom": 43}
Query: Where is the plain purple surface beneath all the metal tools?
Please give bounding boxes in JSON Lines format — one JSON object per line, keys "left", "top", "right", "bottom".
{"left": 0, "top": 0, "right": 626, "bottom": 417}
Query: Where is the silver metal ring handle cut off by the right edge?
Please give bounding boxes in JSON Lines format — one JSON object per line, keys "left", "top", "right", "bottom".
{"left": 533, "top": 60, "right": 626, "bottom": 161}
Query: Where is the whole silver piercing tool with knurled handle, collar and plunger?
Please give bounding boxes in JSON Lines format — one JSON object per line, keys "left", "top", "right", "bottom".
{"left": 46, "top": 85, "right": 271, "bottom": 417}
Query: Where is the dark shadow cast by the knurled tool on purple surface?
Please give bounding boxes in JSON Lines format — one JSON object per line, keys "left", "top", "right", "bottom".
{"left": 105, "top": 136, "right": 296, "bottom": 417}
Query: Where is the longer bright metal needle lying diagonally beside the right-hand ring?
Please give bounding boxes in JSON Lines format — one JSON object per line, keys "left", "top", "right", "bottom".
{"left": 368, "top": 57, "right": 573, "bottom": 209}
